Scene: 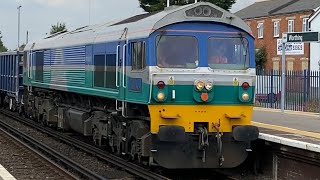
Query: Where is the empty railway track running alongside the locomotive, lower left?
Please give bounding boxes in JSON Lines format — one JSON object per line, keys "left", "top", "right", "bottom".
{"left": 0, "top": 109, "right": 168, "bottom": 180}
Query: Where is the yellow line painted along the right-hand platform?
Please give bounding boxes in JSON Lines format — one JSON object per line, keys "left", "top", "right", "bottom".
{"left": 251, "top": 121, "right": 320, "bottom": 139}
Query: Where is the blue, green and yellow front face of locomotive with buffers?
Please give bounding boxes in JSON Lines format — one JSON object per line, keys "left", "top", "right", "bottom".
{"left": 148, "top": 5, "right": 259, "bottom": 169}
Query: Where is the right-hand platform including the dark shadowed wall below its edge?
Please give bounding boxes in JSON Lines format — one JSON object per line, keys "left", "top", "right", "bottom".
{"left": 252, "top": 108, "right": 320, "bottom": 180}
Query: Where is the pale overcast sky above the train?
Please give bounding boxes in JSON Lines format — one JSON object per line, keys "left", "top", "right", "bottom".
{"left": 0, "top": 0, "right": 255, "bottom": 49}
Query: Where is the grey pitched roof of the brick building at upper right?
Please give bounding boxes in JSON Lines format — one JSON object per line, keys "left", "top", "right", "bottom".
{"left": 235, "top": 0, "right": 320, "bottom": 19}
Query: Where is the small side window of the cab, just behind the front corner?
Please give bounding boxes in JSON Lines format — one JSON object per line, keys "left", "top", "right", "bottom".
{"left": 132, "top": 42, "right": 146, "bottom": 71}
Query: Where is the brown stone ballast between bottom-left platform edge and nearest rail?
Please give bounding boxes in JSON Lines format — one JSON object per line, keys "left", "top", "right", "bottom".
{"left": 0, "top": 124, "right": 76, "bottom": 179}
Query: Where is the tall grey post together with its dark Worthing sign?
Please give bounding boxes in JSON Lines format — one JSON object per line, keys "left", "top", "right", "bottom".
{"left": 281, "top": 32, "right": 320, "bottom": 113}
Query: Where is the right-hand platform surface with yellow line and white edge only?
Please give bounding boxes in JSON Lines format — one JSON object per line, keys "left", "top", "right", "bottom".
{"left": 252, "top": 108, "right": 320, "bottom": 152}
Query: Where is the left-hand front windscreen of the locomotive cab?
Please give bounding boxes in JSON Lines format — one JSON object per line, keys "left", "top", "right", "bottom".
{"left": 156, "top": 35, "right": 198, "bottom": 69}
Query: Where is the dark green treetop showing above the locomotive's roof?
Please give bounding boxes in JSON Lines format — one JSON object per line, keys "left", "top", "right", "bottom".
{"left": 139, "top": 0, "right": 236, "bottom": 12}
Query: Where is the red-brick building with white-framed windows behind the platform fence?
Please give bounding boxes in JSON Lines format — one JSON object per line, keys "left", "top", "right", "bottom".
{"left": 235, "top": 0, "right": 320, "bottom": 71}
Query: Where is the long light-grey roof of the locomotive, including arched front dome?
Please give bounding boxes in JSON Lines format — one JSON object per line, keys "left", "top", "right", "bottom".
{"left": 24, "top": 2, "right": 252, "bottom": 50}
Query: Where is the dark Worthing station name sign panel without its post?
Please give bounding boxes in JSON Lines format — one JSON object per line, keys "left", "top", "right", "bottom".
{"left": 282, "top": 32, "right": 320, "bottom": 43}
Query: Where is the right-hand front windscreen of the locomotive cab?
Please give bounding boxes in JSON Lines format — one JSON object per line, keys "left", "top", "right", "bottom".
{"left": 208, "top": 37, "right": 249, "bottom": 70}
